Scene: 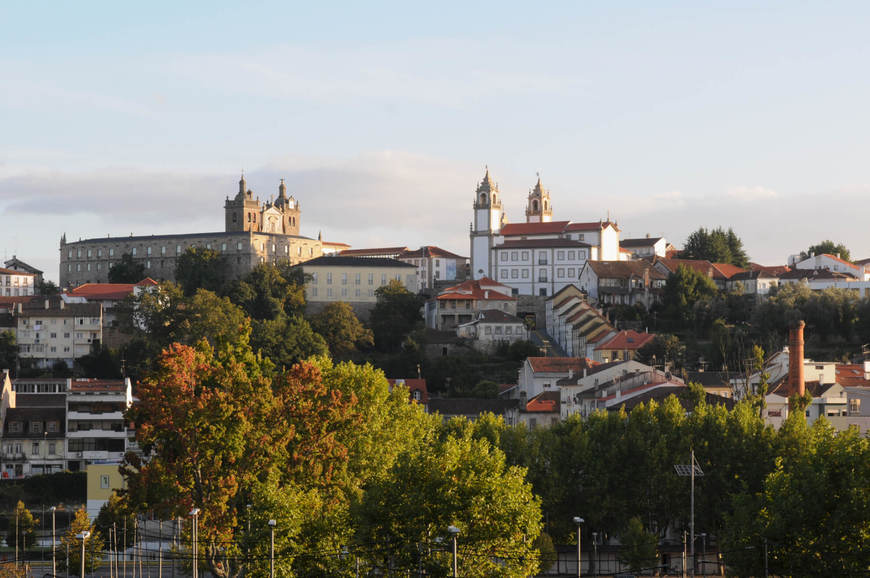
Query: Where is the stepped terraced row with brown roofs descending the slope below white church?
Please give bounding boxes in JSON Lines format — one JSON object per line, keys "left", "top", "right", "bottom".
{"left": 546, "top": 285, "right": 616, "bottom": 357}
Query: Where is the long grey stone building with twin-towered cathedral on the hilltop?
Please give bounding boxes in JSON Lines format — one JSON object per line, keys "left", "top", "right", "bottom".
{"left": 59, "top": 176, "right": 323, "bottom": 288}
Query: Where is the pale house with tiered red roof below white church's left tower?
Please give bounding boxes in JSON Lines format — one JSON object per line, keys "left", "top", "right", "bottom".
{"left": 426, "top": 277, "right": 517, "bottom": 329}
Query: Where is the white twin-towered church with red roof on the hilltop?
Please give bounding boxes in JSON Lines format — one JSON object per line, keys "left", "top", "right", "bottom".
{"left": 470, "top": 168, "right": 628, "bottom": 297}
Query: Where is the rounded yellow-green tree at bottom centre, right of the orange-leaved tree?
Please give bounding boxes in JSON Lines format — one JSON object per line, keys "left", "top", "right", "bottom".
{"left": 354, "top": 431, "right": 541, "bottom": 576}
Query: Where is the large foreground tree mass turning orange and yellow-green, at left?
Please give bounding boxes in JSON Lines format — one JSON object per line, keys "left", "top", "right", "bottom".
{"left": 124, "top": 342, "right": 433, "bottom": 577}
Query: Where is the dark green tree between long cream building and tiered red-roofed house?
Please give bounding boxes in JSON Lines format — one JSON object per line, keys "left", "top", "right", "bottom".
{"left": 369, "top": 279, "right": 423, "bottom": 351}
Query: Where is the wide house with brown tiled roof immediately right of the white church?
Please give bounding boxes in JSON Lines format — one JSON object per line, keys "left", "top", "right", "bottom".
{"left": 579, "top": 261, "right": 667, "bottom": 308}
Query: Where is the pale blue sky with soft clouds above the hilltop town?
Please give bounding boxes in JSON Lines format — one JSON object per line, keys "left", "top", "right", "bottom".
{"left": 0, "top": 1, "right": 870, "bottom": 280}
